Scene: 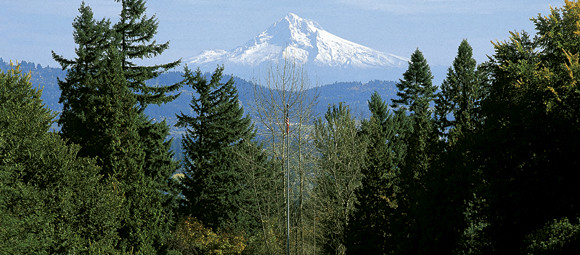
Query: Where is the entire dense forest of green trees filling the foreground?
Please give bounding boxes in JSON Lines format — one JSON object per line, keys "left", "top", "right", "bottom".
{"left": 0, "top": 0, "right": 580, "bottom": 254}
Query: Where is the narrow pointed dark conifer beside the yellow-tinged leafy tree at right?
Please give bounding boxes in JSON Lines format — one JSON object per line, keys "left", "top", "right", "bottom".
{"left": 406, "top": 40, "right": 492, "bottom": 253}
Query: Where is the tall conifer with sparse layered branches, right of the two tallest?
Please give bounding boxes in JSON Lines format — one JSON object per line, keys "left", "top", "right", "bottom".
{"left": 112, "top": 0, "right": 181, "bottom": 248}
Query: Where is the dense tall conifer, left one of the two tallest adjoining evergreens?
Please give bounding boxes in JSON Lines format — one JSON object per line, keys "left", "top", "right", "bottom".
{"left": 53, "top": 3, "right": 140, "bottom": 179}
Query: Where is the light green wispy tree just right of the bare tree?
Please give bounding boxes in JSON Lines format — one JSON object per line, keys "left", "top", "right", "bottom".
{"left": 314, "top": 104, "right": 366, "bottom": 254}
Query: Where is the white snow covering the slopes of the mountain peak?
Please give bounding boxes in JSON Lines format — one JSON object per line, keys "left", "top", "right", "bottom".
{"left": 189, "top": 13, "right": 408, "bottom": 82}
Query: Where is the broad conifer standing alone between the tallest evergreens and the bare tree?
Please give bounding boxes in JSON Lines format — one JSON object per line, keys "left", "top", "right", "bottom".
{"left": 177, "top": 67, "right": 256, "bottom": 233}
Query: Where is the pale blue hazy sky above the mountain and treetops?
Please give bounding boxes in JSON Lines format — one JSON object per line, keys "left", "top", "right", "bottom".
{"left": 0, "top": 0, "right": 564, "bottom": 67}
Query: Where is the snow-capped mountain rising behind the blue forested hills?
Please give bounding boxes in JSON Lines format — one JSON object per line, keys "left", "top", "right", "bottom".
{"left": 188, "top": 13, "right": 408, "bottom": 83}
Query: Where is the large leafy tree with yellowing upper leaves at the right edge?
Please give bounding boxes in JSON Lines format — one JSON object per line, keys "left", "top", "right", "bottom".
{"left": 475, "top": 1, "right": 580, "bottom": 253}
